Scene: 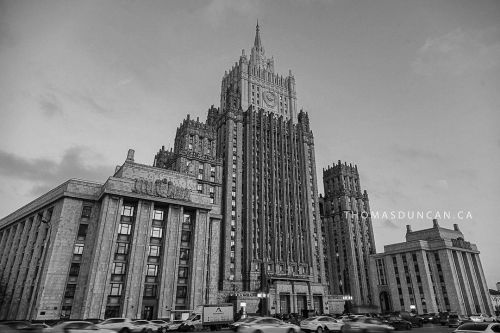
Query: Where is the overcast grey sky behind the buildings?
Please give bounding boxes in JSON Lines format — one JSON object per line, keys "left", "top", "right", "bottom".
{"left": 0, "top": 0, "right": 500, "bottom": 288}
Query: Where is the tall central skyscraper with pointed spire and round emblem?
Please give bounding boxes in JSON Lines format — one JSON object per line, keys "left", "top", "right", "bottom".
{"left": 155, "top": 24, "right": 327, "bottom": 313}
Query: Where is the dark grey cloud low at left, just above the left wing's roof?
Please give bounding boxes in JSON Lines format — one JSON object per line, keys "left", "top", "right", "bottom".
{"left": 0, "top": 147, "right": 113, "bottom": 195}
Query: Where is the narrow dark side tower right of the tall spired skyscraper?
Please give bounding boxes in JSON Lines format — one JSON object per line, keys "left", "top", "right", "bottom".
{"left": 322, "top": 161, "right": 376, "bottom": 312}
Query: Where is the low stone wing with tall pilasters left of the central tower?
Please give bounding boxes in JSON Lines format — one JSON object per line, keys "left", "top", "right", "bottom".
{"left": 0, "top": 151, "right": 222, "bottom": 320}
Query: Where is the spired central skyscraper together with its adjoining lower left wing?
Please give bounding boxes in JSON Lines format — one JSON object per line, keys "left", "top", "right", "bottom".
{"left": 0, "top": 26, "right": 329, "bottom": 320}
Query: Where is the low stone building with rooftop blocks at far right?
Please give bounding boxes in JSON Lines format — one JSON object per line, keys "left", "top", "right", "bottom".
{"left": 370, "top": 220, "right": 493, "bottom": 315}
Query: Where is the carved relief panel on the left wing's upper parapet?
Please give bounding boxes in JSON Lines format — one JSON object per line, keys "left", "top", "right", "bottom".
{"left": 133, "top": 178, "right": 191, "bottom": 201}
